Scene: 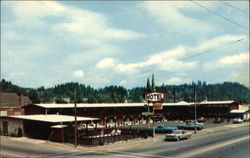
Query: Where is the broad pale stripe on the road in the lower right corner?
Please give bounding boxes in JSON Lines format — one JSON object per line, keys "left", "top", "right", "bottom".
{"left": 176, "top": 136, "right": 249, "bottom": 158}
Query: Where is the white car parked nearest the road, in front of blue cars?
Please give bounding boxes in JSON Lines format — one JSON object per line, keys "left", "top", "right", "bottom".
{"left": 165, "top": 130, "right": 192, "bottom": 141}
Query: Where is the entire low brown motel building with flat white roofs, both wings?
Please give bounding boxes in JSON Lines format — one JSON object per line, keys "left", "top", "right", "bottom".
{"left": 0, "top": 101, "right": 250, "bottom": 145}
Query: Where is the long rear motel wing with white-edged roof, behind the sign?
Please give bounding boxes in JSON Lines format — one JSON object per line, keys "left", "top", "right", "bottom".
{"left": 24, "top": 101, "right": 248, "bottom": 127}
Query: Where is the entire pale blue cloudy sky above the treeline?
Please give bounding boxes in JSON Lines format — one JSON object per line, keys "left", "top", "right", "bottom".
{"left": 1, "top": 1, "right": 249, "bottom": 88}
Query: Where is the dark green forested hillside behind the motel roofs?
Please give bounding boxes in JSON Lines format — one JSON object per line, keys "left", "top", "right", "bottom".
{"left": 0, "top": 79, "right": 250, "bottom": 103}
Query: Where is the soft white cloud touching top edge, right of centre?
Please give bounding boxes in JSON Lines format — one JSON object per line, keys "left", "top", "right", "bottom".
{"left": 142, "top": 1, "right": 213, "bottom": 33}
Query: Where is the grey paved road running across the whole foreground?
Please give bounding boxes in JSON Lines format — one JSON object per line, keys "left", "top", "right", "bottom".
{"left": 1, "top": 124, "right": 250, "bottom": 158}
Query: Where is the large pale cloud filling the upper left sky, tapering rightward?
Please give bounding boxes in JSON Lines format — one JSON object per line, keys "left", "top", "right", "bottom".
{"left": 3, "top": 1, "right": 145, "bottom": 46}
